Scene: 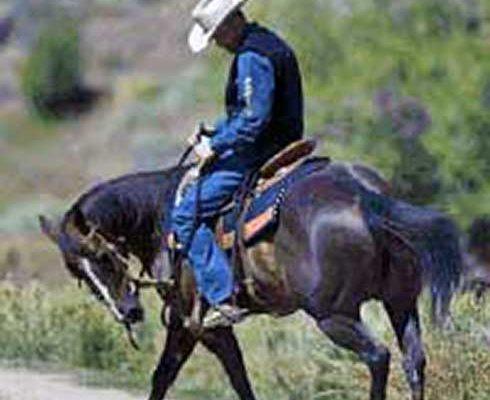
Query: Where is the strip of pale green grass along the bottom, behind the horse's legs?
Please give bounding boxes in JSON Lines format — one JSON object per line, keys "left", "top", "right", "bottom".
{"left": 0, "top": 285, "right": 490, "bottom": 400}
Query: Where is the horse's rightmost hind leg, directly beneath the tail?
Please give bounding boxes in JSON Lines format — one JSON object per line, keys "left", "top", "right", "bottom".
{"left": 385, "top": 303, "right": 425, "bottom": 400}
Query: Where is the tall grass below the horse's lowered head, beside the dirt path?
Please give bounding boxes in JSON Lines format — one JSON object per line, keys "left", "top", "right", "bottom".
{"left": 0, "top": 284, "right": 161, "bottom": 387}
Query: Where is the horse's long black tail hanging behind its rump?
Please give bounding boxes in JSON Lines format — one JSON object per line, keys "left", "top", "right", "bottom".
{"left": 364, "top": 194, "right": 463, "bottom": 323}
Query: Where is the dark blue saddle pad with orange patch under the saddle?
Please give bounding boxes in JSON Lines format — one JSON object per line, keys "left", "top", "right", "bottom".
{"left": 216, "top": 157, "right": 329, "bottom": 250}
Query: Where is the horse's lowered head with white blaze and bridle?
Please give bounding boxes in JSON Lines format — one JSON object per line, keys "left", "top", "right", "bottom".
{"left": 39, "top": 209, "right": 144, "bottom": 327}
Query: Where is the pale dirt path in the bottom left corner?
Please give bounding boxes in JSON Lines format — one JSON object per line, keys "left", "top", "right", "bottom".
{"left": 0, "top": 368, "right": 143, "bottom": 400}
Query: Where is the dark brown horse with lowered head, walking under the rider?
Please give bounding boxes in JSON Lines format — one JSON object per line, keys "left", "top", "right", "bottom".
{"left": 41, "top": 161, "right": 461, "bottom": 400}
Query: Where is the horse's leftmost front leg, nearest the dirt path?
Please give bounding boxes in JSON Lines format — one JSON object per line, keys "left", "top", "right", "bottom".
{"left": 149, "top": 318, "right": 197, "bottom": 400}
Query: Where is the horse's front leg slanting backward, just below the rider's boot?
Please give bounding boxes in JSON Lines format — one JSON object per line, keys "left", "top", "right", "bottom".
{"left": 200, "top": 328, "right": 255, "bottom": 400}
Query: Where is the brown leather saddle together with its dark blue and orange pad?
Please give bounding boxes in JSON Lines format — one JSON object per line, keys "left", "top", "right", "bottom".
{"left": 215, "top": 140, "right": 329, "bottom": 250}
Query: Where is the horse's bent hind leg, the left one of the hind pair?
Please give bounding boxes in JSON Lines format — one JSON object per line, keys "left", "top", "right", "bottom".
{"left": 318, "top": 315, "right": 390, "bottom": 400}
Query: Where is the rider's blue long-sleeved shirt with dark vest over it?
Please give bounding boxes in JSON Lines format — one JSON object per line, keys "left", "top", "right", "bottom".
{"left": 211, "top": 24, "right": 303, "bottom": 169}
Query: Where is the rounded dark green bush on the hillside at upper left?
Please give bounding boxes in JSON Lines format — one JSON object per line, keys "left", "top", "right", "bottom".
{"left": 21, "top": 16, "right": 82, "bottom": 117}
